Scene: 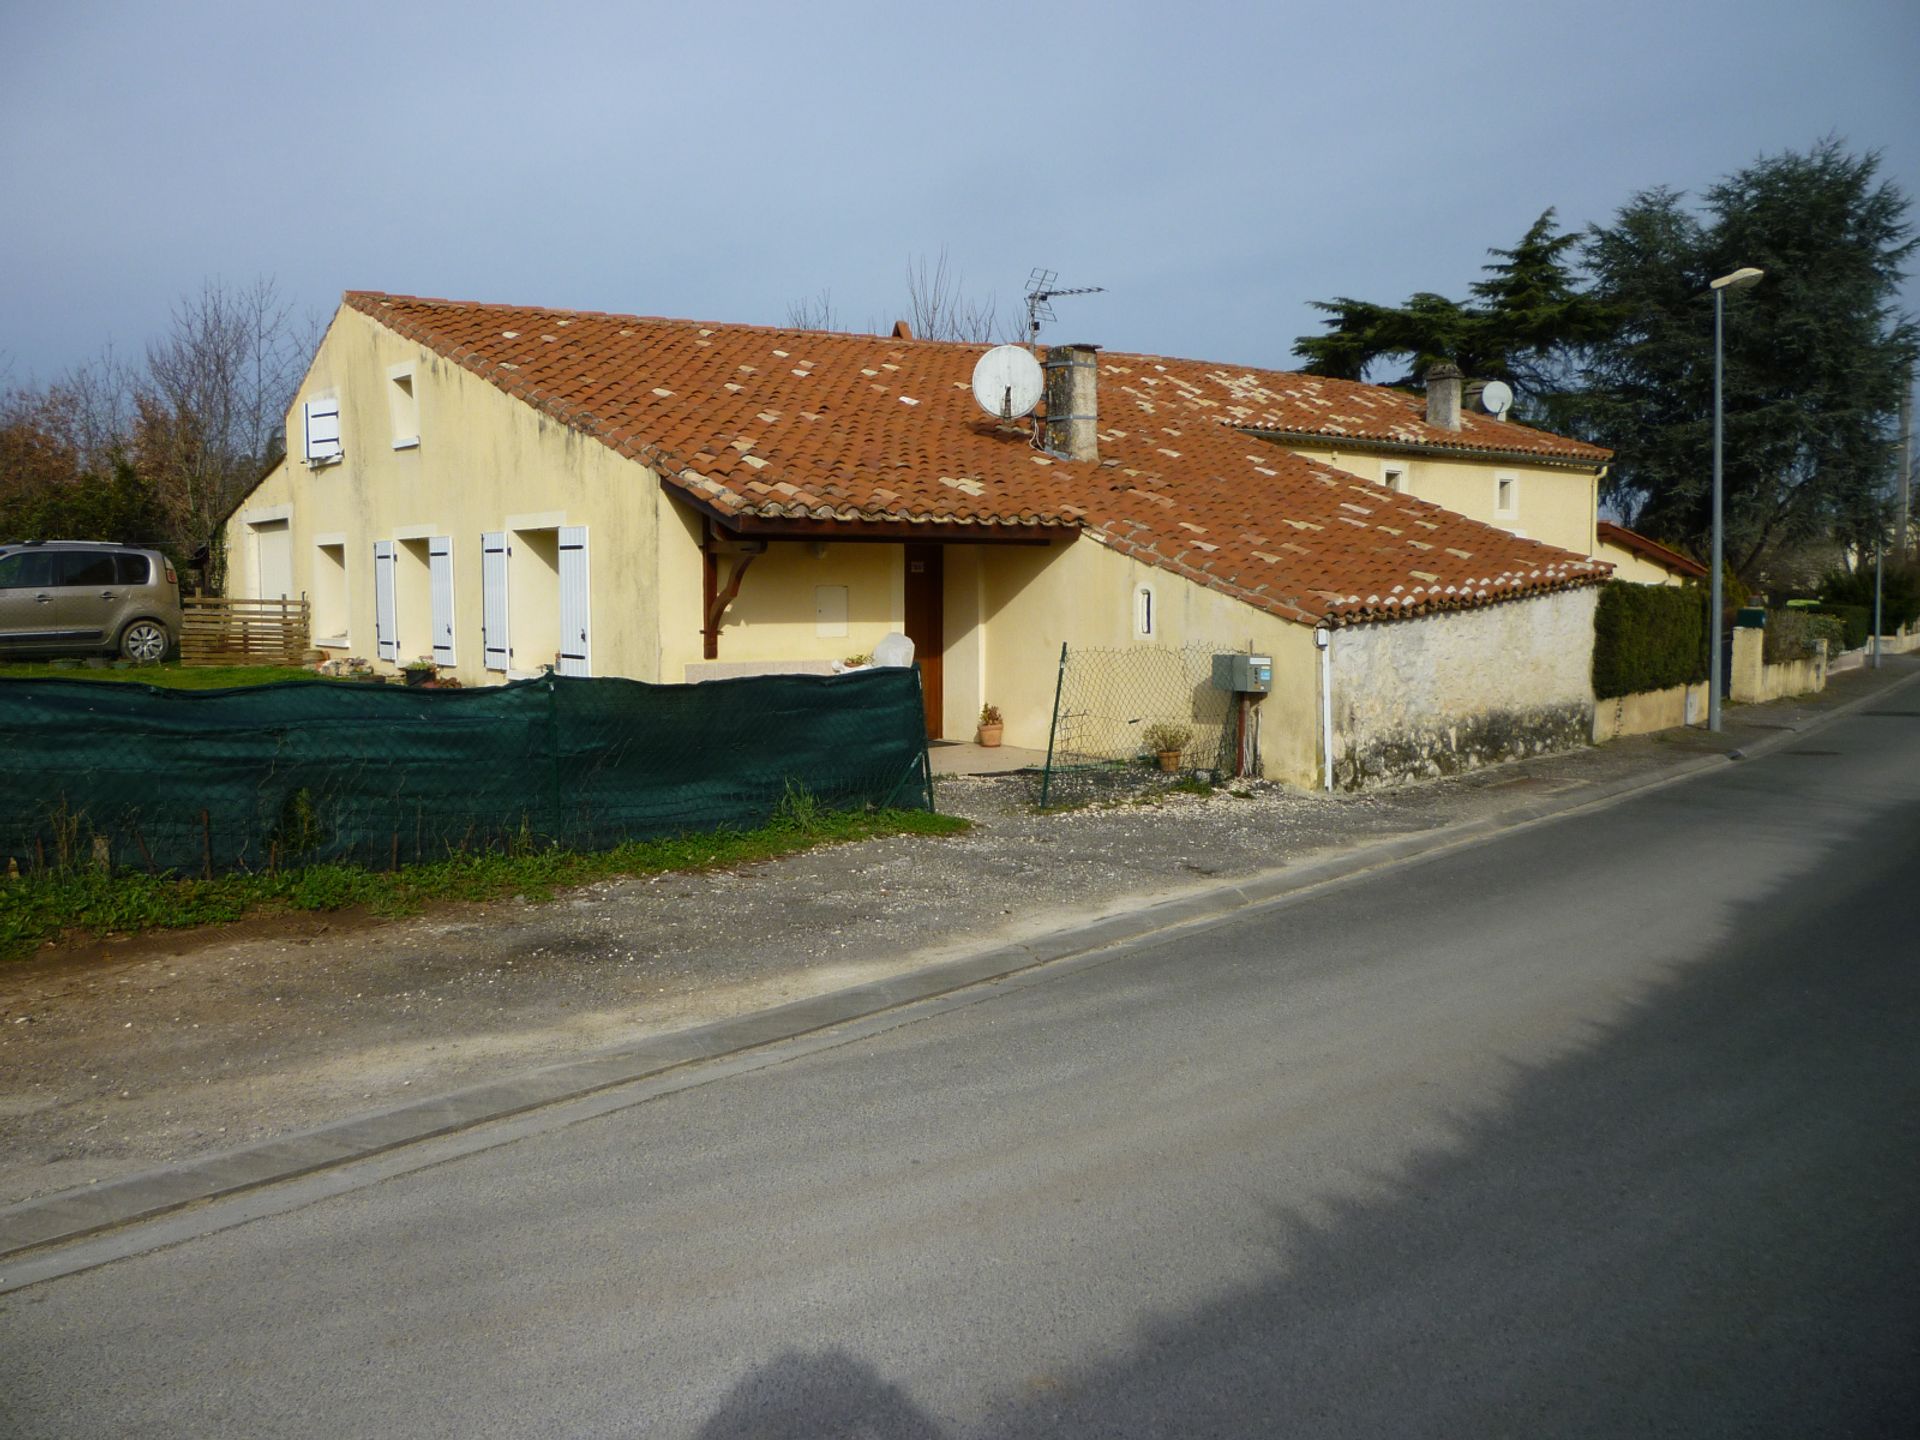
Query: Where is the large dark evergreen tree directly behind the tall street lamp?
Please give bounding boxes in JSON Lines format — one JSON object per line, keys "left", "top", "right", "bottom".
{"left": 1565, "top": 138, "right": 1920, "bottom": 574}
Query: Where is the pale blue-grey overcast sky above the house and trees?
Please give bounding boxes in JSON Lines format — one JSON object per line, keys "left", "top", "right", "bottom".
{"left": 0, "top": 0, "right": 1920, "bottom": 384}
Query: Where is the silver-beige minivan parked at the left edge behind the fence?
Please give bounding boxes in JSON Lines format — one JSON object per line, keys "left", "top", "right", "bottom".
{"left": 0, "top": 540, "right": 180, "bottom": 662}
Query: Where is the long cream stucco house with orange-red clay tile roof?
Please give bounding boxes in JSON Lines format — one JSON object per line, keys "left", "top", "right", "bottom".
{"left": 227, "top": 292, "right": 1609, "bottom": 783}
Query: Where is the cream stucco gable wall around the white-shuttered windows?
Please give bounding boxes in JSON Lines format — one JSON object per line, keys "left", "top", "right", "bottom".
{"left": 227, "top": 307, "right": 660, "bottom": 685}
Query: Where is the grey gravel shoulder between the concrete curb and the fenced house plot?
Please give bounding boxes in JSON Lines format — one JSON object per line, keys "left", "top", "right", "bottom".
{"left": 0, "top": 657, "right": 1920, "bottom": 1204}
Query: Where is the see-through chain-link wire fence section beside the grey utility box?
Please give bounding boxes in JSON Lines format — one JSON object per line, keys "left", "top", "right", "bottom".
{"left": 1029, "top": 645, "right": 1246, "bottom": 806}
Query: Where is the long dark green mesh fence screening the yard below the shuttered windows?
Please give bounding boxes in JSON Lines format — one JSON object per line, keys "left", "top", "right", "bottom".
{"left": 0, "top": 668, "right": 933, "bottom": 874}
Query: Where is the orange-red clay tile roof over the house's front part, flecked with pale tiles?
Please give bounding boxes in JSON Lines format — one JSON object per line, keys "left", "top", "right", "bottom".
{"left": 346, "top": 292, "right": 1611, "bottom": 624}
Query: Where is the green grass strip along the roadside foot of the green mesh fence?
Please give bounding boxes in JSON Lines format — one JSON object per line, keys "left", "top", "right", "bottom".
{"left": 0, "top": 806, "right": 968, "bottom": 960}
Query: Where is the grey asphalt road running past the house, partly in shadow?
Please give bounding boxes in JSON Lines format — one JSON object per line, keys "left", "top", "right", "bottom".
{"left": 0, "top": 685, "right": 1920, "bottom": 1440}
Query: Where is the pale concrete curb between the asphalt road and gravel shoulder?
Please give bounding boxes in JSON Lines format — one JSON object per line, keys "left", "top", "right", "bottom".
{"left": 0, "top": 674, "right": 1920, "bottom": 1259}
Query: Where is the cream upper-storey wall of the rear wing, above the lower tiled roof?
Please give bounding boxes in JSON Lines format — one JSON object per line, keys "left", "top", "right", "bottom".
{"left": 1288, "top": 445, "right": 1599, "bottom": 555}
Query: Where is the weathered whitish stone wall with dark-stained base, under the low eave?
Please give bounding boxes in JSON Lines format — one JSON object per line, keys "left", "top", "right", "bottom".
{"left": 1332, "top": 586, "right": 1599, "bottom": 789}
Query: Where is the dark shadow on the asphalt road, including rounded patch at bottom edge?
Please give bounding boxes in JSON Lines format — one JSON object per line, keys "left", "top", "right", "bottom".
{"left": 699, "top": 794, "right": 1920, "bottom": 1440}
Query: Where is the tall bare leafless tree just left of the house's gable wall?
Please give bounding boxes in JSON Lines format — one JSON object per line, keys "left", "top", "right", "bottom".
{"left": 136, "top": 278, "right": 317, "bottom": 549}
